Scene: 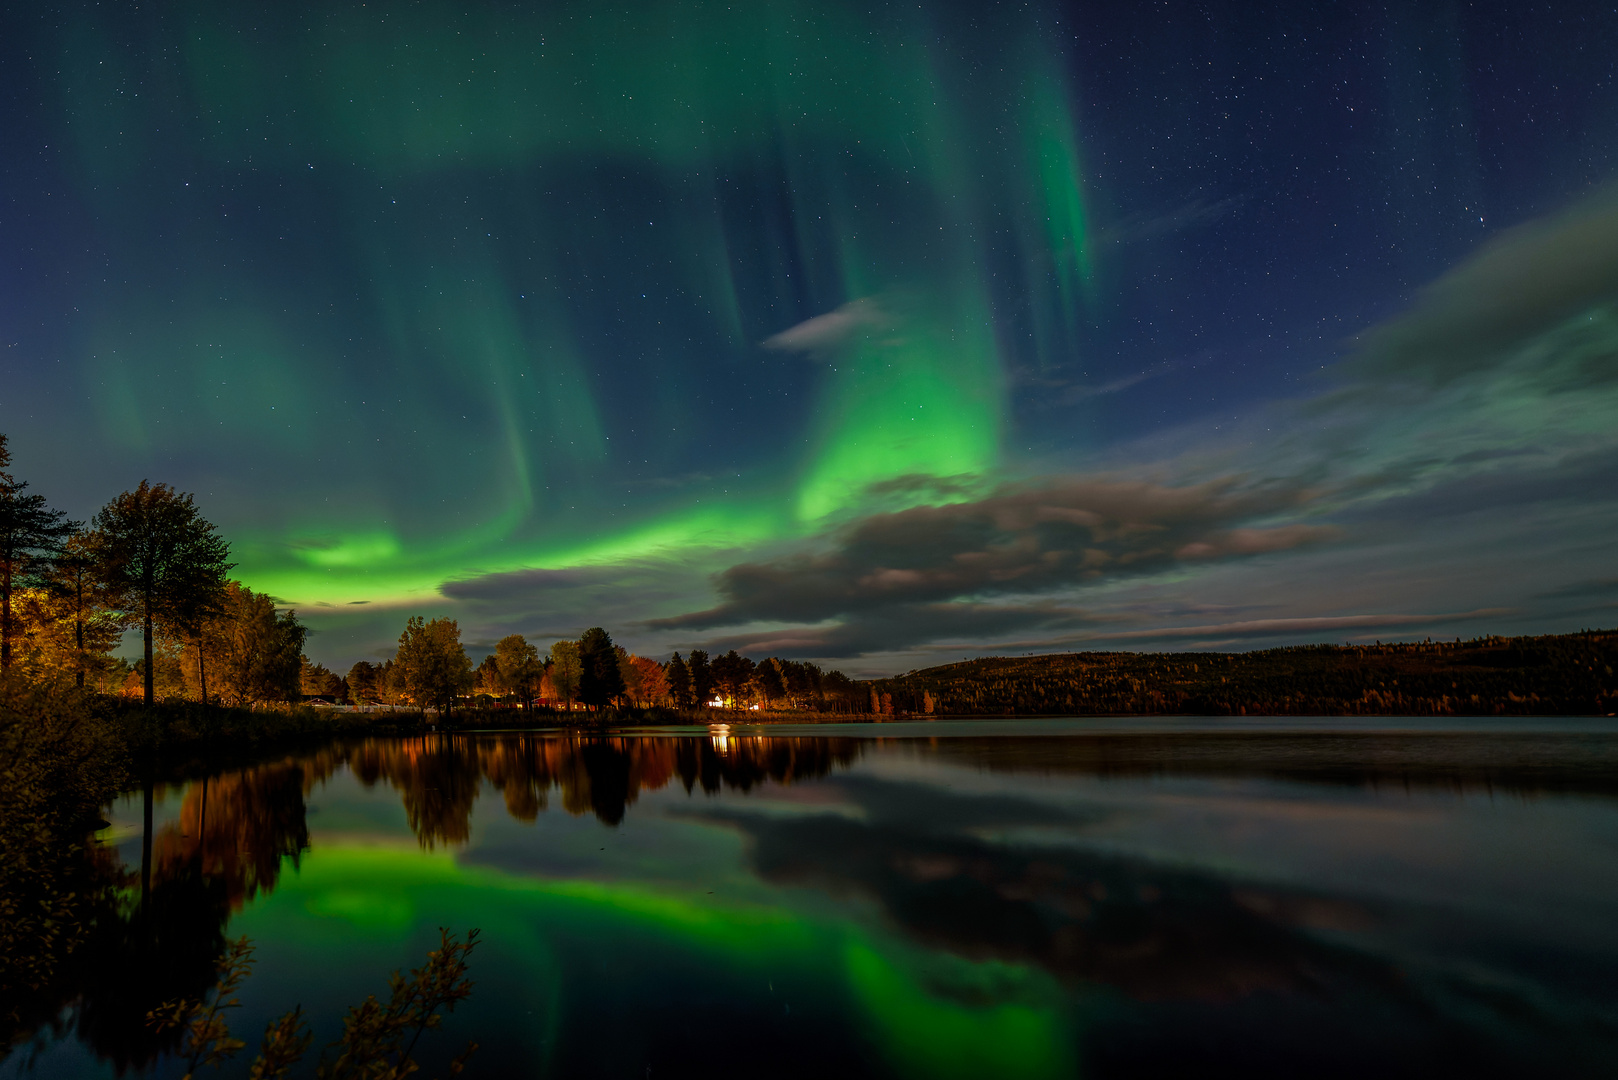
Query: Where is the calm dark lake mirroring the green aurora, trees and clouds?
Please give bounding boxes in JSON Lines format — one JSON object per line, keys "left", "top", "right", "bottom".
{"left": 0, "top": 717, "right": 1618, "bottom": 1080}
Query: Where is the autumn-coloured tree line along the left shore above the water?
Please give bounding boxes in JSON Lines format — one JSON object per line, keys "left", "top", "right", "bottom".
{"left": 0, "top": 434, "right": 867, "bottom": 714}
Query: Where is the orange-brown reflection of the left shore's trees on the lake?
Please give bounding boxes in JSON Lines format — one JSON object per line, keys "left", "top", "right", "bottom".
{"left": 19, "top": 735, "right": 859, "bottom": 1074}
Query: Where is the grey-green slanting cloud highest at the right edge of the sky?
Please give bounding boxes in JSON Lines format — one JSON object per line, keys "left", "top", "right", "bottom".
{"left": 1359, "top": 191, "right": 1618, "bottom": 384}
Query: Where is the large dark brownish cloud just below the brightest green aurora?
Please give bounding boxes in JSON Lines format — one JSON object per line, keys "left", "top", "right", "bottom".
{"left": 649, "top": 478, "right": 1332, "bottom": 649}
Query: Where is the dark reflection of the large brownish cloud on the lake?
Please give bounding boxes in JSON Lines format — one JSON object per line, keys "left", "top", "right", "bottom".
{"left": 681, "top": 777, "right": 1406, "bottom": 1003}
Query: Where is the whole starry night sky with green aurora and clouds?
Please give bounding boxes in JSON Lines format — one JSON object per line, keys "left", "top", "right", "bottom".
{"left": 0, "top": 0, "right": 1618, "bottom": 674}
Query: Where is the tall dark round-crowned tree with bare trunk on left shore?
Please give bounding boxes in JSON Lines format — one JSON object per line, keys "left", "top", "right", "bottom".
{"left": 94, "top": 479, "right": 231, "bottom": 704}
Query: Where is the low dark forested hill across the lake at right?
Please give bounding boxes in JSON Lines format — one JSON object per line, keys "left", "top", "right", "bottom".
{"left": 870, "top": 630, "right": 1618, "bottom": 716}
